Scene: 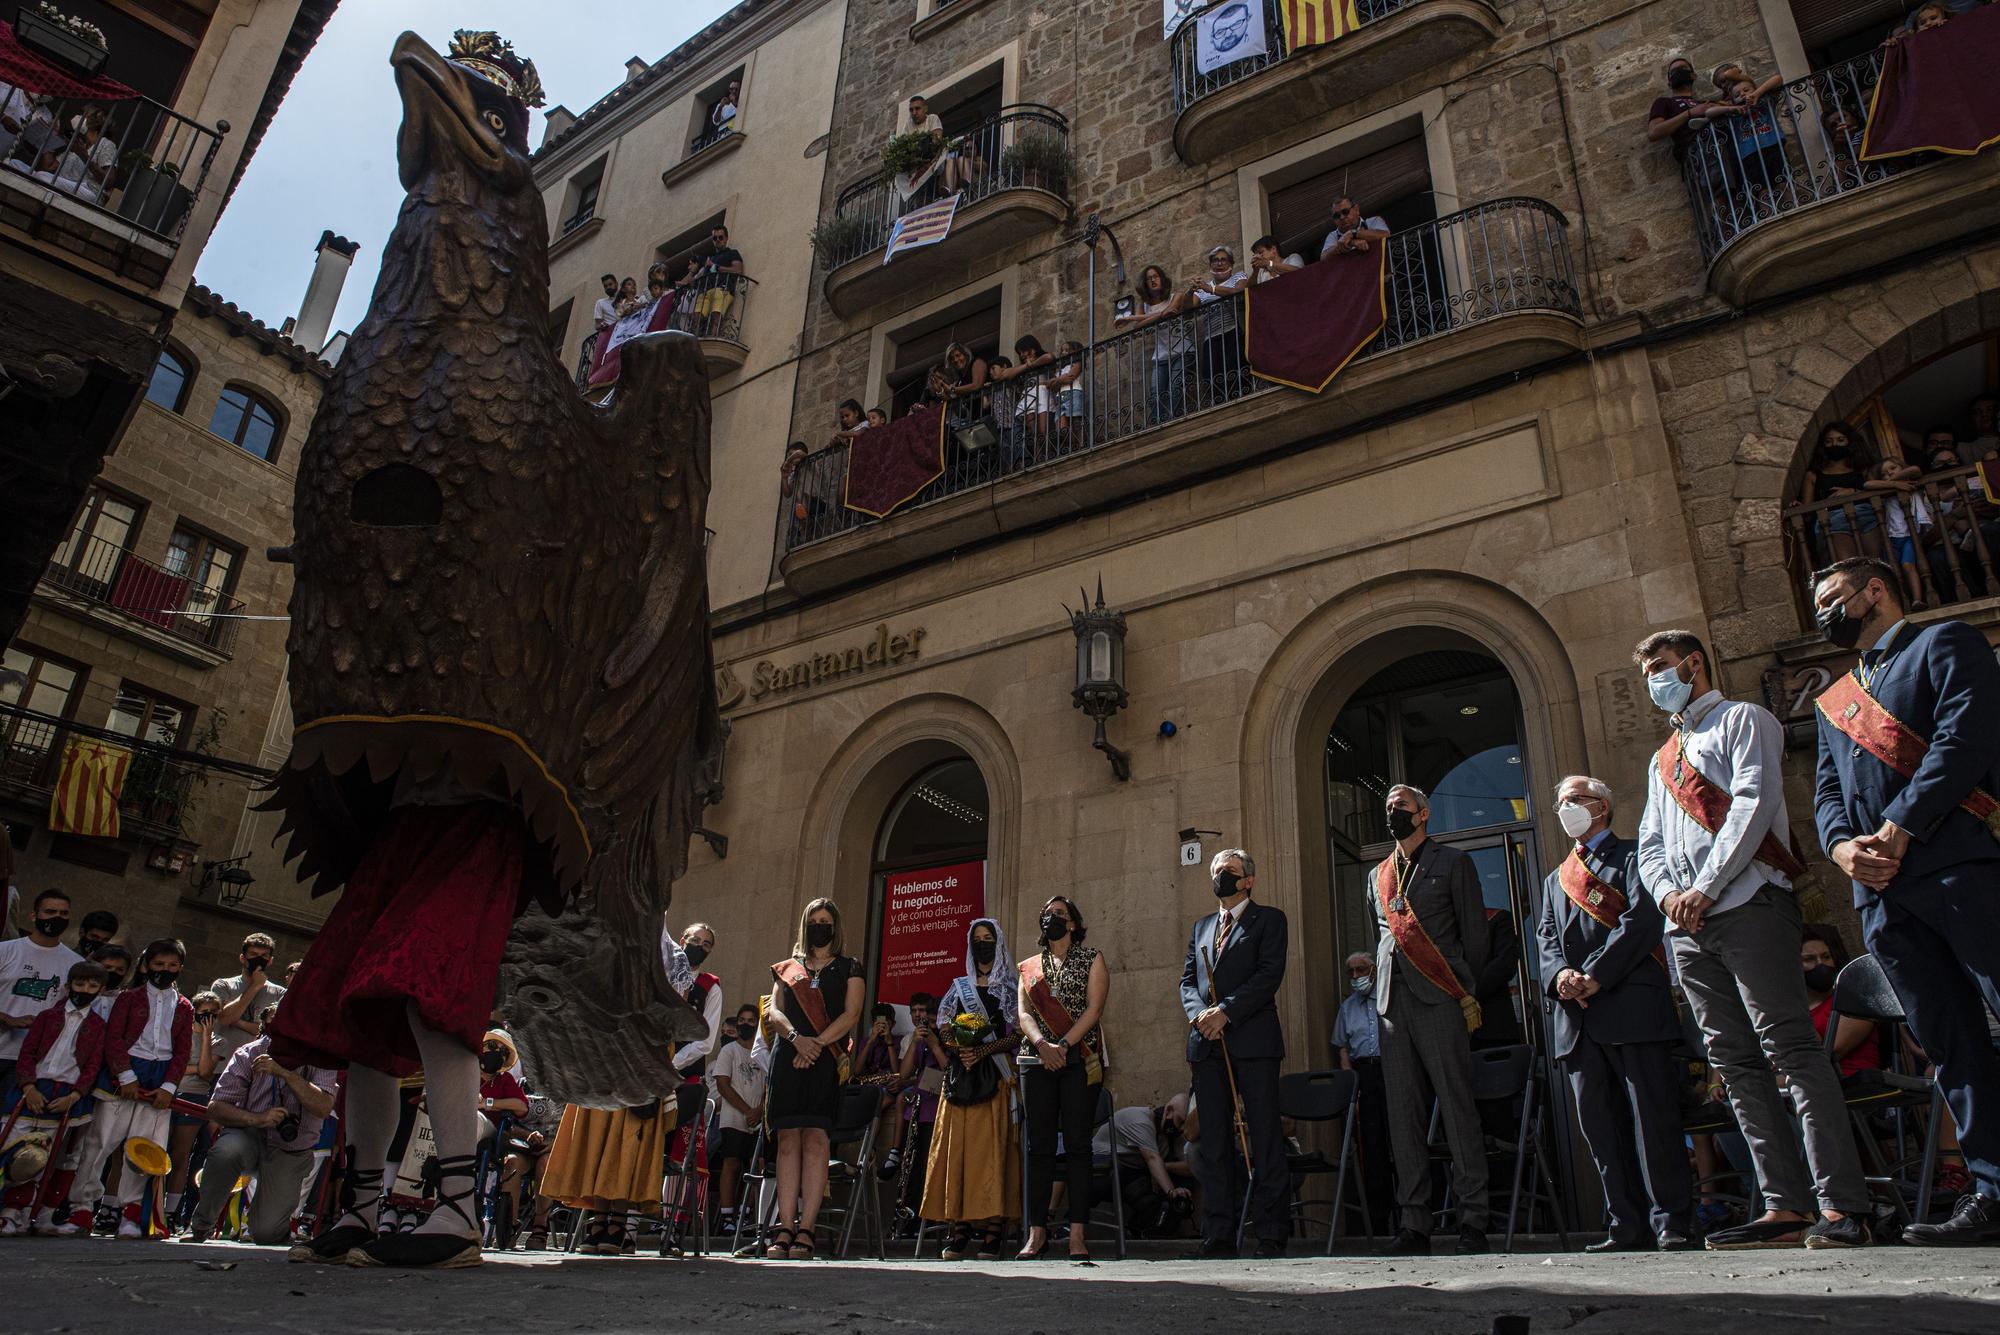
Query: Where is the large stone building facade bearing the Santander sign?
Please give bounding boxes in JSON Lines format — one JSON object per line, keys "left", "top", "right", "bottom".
{"left": 676, "top": 0, "right": 2000, "bottom": 1151}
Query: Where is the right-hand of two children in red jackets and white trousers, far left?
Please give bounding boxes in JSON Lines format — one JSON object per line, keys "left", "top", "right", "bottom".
{"left": 70, "top": 939, "right": 194, "bottom": 1237}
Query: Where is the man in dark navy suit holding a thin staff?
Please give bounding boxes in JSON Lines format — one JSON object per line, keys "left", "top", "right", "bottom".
{"left": 1180, "top": 847, "right": 1292, "bottom": 1257}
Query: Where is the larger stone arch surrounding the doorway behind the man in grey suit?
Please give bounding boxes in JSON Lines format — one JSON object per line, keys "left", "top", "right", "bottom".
{"left": 1240, "top": 570, "right": 1588, "bottom": 1053}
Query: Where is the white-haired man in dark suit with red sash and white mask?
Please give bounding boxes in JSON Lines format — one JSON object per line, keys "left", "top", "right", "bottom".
{"left": 1534, "top": 773, "right": 1694, "bottom": 1251}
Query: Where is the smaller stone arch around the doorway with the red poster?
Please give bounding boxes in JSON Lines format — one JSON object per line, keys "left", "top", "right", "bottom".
{"left": 792, "top": 693, "right": 1022, "bottom": 935}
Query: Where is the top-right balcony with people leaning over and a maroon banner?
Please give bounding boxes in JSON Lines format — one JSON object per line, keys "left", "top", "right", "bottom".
{"left": 1650, "top": 4, "right": 2000, "bottom": 306}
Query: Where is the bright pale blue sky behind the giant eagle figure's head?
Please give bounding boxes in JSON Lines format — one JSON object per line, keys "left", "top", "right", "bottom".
{"left": 196, "top": 0, "right": 734, "bottom": 343}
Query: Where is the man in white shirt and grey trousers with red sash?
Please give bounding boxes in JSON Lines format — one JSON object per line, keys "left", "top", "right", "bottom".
{"left": 1632, "top": 630, "right": 1870, "bottom": 1251}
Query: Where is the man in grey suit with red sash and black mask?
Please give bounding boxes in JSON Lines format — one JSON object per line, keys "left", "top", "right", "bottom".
{"left": 1368, "top": 783, "right": 1488, "bottom": 1255}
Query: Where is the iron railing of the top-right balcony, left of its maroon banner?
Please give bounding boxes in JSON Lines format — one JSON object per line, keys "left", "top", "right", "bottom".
{"left": 1680, "top": 50, "right": 1934, "bottom": 260}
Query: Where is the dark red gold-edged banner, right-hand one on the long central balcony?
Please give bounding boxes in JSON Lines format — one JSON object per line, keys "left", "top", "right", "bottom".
{"left": 1244, "top": 242, "right": 1388, "bottom": 394}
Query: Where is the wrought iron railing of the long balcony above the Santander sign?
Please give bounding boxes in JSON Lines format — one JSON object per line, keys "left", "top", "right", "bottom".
{"left": 778, "top": 198, "right": 1582, "bottom": 556}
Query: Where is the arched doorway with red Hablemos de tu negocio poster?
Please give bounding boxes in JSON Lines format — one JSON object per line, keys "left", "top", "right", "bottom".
{"left": 850, "top": 745, "right": 988, "bottom": 1005}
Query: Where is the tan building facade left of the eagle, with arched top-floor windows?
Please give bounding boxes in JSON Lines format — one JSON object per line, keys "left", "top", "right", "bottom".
{"left": 0, "top": 284, "right": 330, "bottom": 977}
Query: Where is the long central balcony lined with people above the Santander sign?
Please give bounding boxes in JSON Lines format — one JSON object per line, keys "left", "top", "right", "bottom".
{"left": 776, "top": 194, "right": 1582, "bottom": 594}
